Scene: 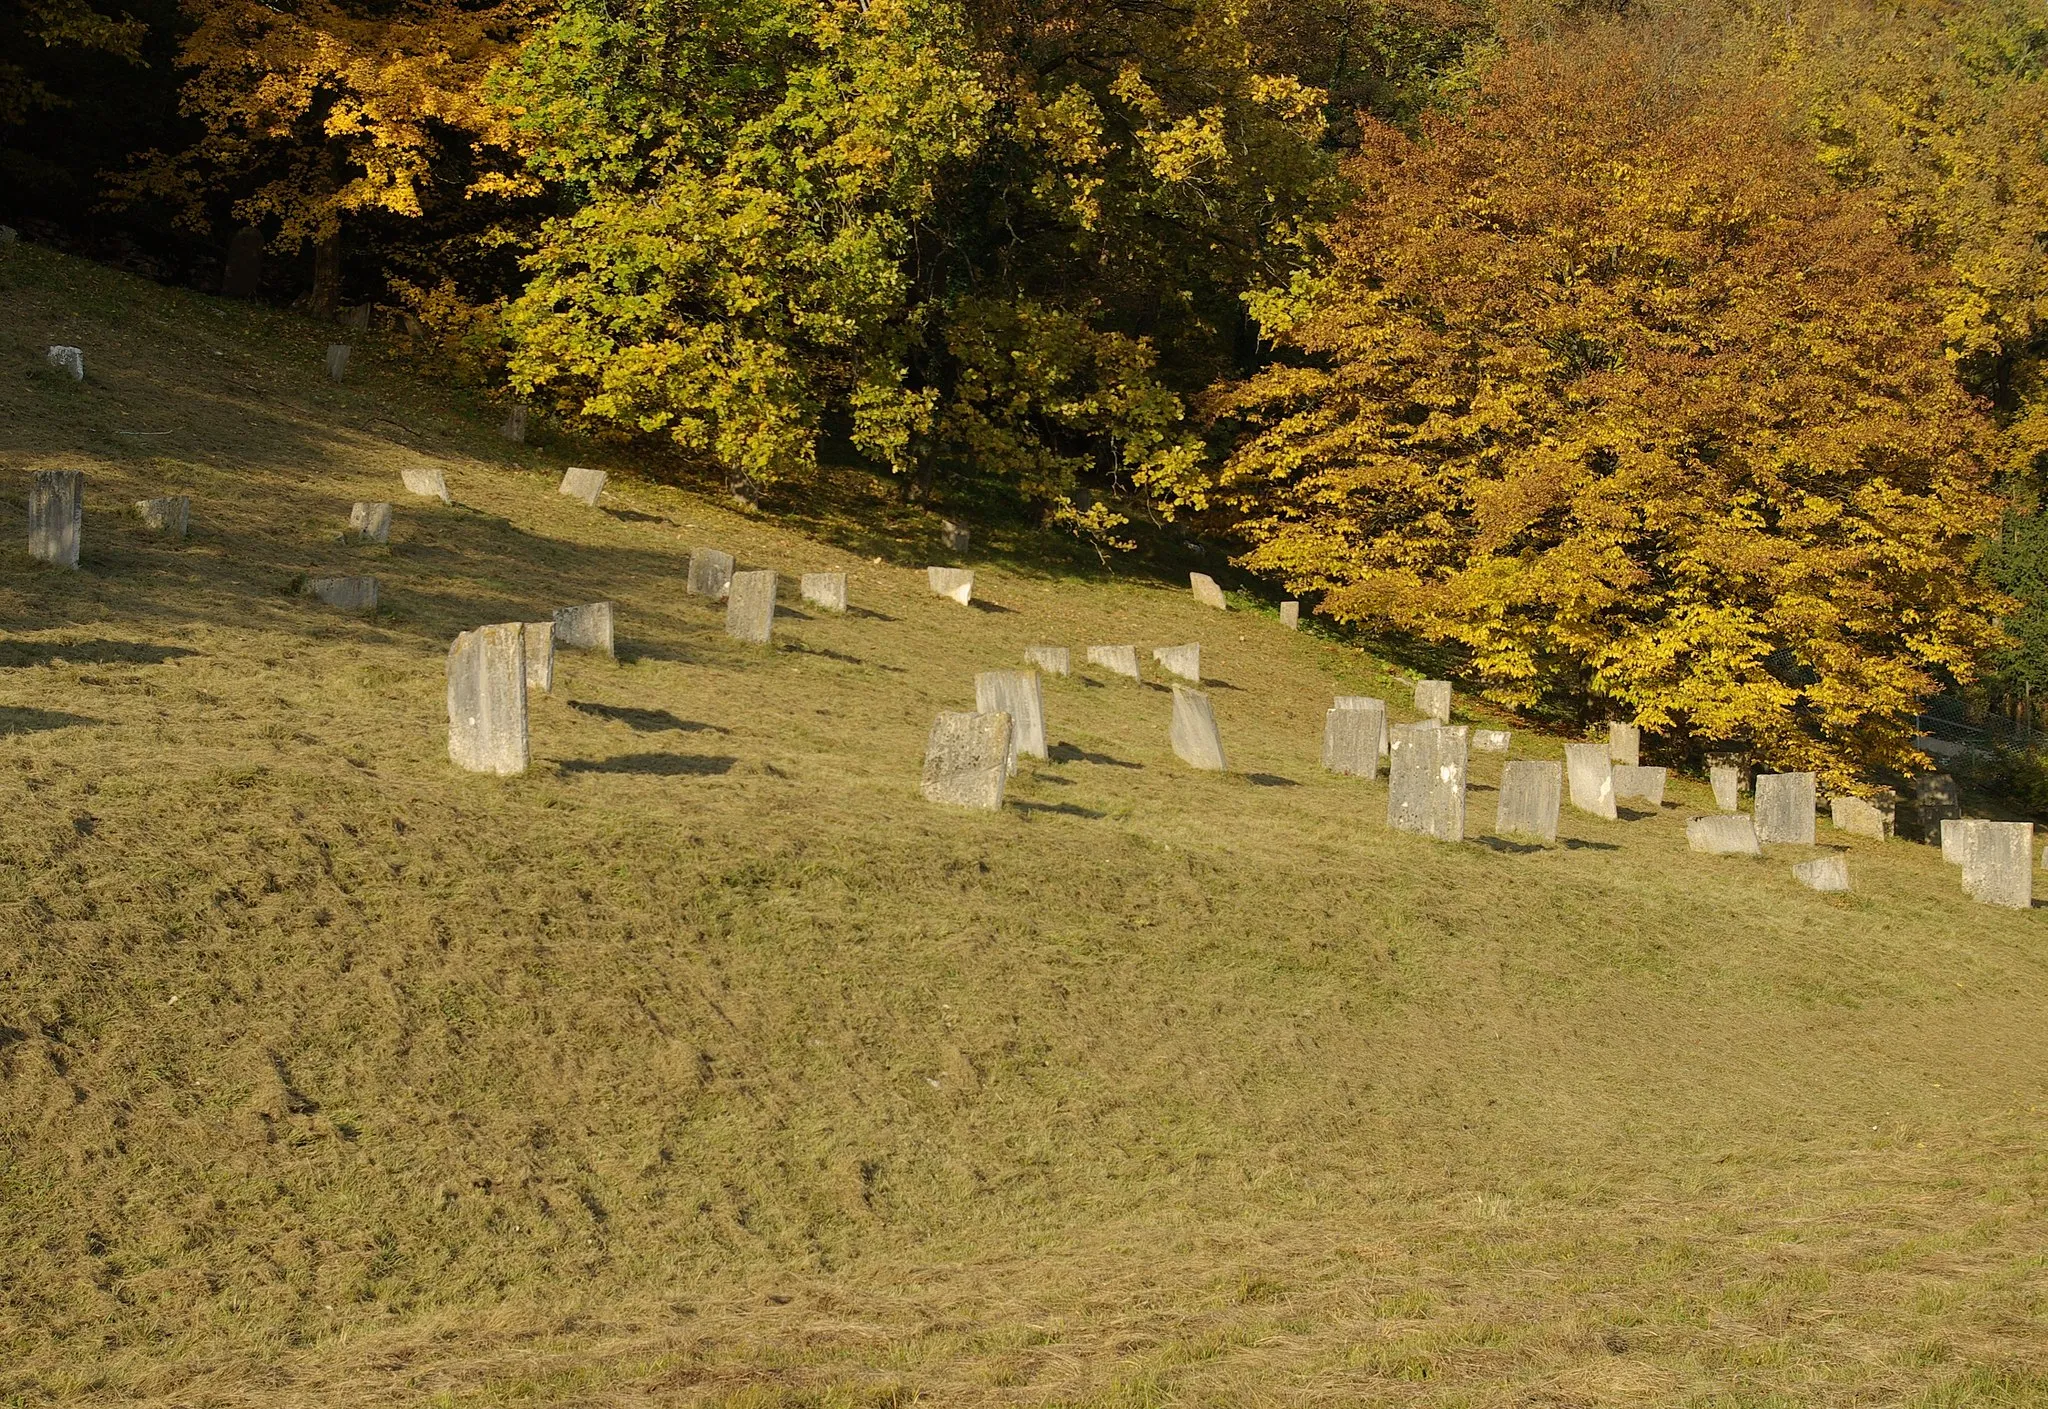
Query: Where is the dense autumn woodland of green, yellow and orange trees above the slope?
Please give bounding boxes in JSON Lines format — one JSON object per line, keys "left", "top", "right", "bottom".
{"left": 0, "top": 0, "right": 2048, "bottom": 784}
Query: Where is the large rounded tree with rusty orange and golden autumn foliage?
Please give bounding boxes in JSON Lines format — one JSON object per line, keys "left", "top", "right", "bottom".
{"left": 1196, "top": 25, "right": 2005, "bottom": 784}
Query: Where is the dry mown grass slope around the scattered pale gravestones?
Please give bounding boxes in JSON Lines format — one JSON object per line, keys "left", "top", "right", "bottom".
{"left": 0, "top": 248, "right": 2048, "bottom": 1409}
